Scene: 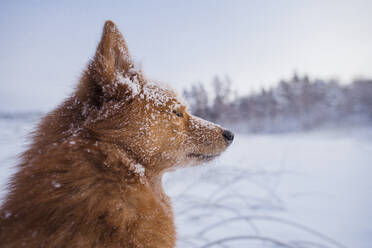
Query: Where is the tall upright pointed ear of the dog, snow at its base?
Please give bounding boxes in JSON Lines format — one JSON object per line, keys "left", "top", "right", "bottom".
{"left": 87, "top": 21, "right": 142, "bottom": 101}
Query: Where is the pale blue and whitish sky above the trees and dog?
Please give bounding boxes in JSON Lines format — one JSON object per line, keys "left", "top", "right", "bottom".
{"left": 0, "top": 0, "right": 372, "bottom": 112}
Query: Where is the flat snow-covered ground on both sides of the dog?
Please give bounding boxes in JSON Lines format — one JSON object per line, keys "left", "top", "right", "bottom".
{"left": 0, "top": 116, "right": 372, "bottom": 248}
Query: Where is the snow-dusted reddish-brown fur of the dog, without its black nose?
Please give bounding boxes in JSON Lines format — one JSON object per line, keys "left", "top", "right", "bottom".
{"left": 0, "top": 21, "right": 232, "bottom": 248}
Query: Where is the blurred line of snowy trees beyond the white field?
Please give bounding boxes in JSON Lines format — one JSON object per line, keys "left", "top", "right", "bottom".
{"left": 183, "top": 73, "right": 372, "bottom": 132}
